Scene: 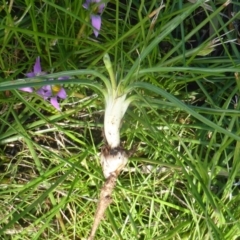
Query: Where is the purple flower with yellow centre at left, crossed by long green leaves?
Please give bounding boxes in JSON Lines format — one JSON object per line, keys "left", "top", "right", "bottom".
{"left": 20, "top": 57, "right": 69, "bottom": 111}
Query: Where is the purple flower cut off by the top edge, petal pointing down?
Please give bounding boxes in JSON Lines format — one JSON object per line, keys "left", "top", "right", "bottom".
{"left": 83, "top": 0, "right": 105, "bottom": 37}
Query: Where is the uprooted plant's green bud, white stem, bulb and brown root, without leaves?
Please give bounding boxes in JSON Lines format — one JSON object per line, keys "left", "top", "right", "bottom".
{"left": 88, "top": 54, "right": 130, "bottom": 240}
